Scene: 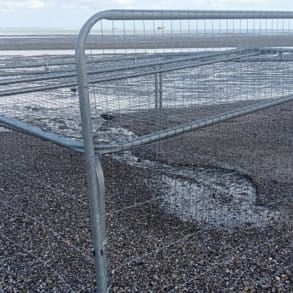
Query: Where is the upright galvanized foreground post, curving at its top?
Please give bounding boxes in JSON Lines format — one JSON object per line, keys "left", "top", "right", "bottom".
{"left": 76, "top": 11, "right": 107, "bottom": 293}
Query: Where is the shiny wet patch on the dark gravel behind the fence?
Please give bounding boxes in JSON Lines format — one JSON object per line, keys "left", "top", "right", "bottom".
{"left": 111, "top": 130, "right": 280, "bottom": 228}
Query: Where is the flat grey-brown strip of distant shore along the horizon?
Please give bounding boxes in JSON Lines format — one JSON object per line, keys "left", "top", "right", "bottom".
{"left": 0, "top": 33, "right": 292, "bottom": 51}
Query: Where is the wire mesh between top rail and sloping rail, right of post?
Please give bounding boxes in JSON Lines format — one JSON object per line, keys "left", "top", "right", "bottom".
{"left": 78, "top": 12, "right": 292, "bottom": 152}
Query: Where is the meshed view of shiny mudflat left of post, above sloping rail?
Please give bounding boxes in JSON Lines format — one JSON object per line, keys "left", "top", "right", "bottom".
{"left": 0, "top": 55, "right": 85, "bottom": 151}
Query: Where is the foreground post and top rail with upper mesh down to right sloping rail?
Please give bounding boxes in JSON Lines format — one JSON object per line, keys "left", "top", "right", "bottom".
{"left": 76, "top": 10, "right": 293, "bottom": 292}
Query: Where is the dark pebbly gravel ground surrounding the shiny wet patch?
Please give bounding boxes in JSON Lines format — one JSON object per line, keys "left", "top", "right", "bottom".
{"left": 0, "top": 103, "right": 293, "bottom": 292}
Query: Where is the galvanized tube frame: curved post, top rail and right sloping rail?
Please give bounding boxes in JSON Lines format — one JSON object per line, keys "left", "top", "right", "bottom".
{"left": 75, "top": 10, "right": 293, "bottom": 292}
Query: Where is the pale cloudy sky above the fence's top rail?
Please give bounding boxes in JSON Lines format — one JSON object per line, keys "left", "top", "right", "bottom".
{"left": 0, "top": 0, "right": 293, "bottom": 29}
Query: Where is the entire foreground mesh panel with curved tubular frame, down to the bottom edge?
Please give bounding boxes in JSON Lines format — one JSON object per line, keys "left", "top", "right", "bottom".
{"left": 77, "top": 11, "right": 293, "bottom": 292}
